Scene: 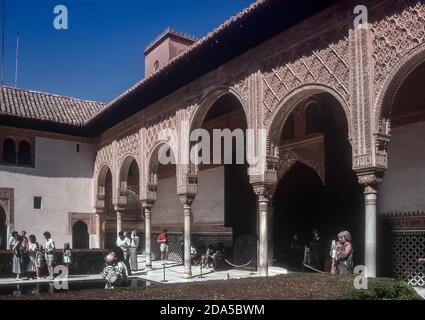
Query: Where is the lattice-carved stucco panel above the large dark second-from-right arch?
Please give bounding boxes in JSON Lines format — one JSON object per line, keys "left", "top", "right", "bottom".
{"left": 261, "top": 26, "right": 350, "bottom": 126}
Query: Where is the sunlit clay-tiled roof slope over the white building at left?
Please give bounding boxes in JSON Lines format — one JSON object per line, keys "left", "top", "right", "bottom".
{"left": 0, "top": 86, "right": 107, "bottom": 126}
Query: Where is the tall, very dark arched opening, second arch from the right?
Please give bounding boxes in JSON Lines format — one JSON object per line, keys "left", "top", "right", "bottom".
{"left": 271, "top": 93, "right": 364, "bottom": 271}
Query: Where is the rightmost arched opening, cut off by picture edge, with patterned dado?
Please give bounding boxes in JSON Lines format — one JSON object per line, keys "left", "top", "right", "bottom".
{"left": 377, "top": 59, "right": 425, "bottom": 286}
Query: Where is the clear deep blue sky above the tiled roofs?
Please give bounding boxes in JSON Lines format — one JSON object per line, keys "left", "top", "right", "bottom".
{"left": 0, "top": 0, "right": 254, "bottom": 102}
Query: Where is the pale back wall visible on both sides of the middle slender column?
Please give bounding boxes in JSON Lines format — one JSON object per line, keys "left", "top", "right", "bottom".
{"left": 152, "top": 167, "right": 224, "bottom": 225}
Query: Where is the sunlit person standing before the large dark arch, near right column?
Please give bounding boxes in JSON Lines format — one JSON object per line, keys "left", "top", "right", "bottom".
{"left": 335, "top": 231, "right": 354, "bottom": 274}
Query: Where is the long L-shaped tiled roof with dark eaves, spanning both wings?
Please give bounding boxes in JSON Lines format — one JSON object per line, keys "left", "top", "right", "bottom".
{"left": 0, "top": 0, "right": 342, "bottom": 136}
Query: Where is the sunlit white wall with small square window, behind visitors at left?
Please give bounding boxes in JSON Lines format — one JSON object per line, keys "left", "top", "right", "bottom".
{"left": 0, "top": 138, "right": 94, "bottom": 248}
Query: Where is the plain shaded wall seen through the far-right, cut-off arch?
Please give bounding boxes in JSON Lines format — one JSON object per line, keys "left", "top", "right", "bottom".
{"left": 378, "top": 122, "right": 425, "bottom": 213}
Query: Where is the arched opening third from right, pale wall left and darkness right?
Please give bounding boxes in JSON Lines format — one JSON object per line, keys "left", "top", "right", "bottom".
{"left": 193, "top": 93, "right": 257, "bottom": 263}
